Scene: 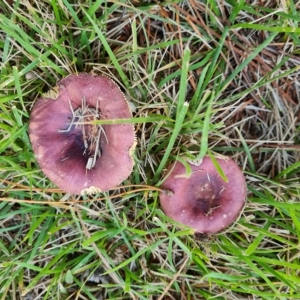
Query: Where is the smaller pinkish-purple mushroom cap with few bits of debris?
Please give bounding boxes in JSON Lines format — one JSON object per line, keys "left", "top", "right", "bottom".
{"left": 160, "top": 157, "right": 246, "bottom": 234}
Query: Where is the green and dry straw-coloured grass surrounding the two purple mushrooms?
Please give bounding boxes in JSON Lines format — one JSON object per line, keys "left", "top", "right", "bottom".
{"left": 0, "top": 0, "right": 300, "bottom": 300}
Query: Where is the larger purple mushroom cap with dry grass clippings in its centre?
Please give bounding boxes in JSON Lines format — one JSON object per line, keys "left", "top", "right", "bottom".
{"left": 29, "top": 73, "right": 136, "bottom": 194}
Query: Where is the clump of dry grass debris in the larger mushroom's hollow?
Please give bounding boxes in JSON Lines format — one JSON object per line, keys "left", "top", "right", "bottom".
{"left": 59, "top": 98, "right": 108, "bottom": 170}
